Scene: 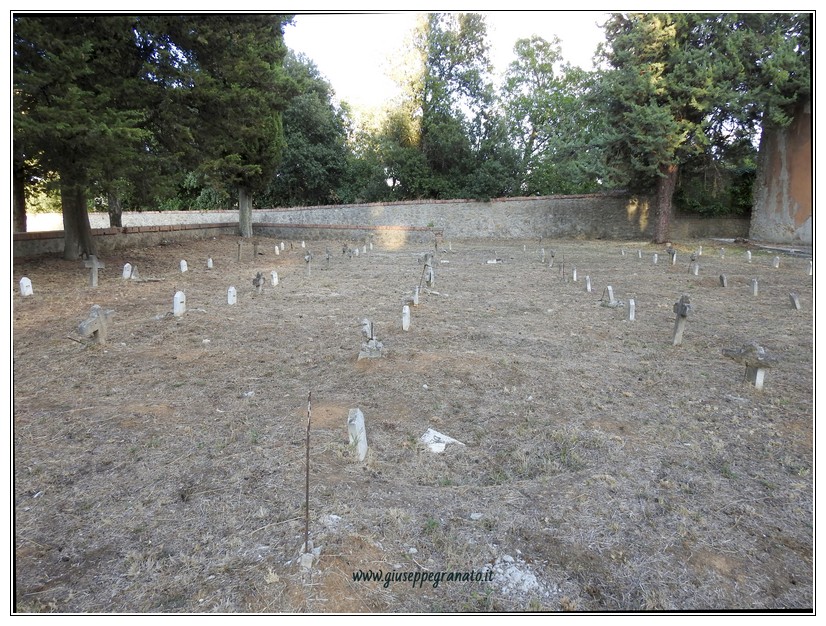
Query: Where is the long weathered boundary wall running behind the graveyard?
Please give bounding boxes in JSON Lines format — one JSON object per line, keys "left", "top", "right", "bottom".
{"left": 13, "top": 194, "right": 749, "bottom": 257}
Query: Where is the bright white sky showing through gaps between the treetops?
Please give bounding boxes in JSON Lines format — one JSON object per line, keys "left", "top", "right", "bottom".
{"left": 284, "top": 11, "right": 607, "bottom": 108}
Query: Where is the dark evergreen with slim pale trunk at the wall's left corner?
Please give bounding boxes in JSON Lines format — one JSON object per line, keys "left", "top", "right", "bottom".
{"left": 166, "top": 15, "right": 295, "bottom": 237}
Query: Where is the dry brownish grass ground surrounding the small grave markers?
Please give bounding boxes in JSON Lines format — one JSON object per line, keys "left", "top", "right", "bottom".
{"left": 12, "top": 237, "right": 814, "bottom": 613}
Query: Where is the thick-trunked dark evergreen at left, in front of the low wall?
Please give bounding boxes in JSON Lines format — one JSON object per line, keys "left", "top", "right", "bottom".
{"left": 13, "top": 15, "right": 147, "bottom": 259}
